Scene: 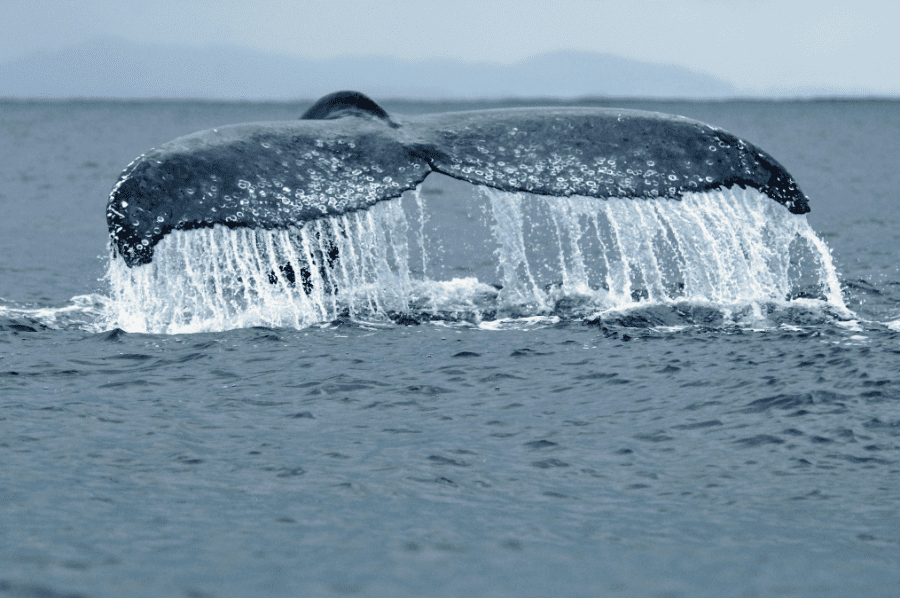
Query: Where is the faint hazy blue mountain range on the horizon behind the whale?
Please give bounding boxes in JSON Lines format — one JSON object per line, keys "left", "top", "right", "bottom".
{"left": 0, "top": 38, "right": 738, "bottom": 100}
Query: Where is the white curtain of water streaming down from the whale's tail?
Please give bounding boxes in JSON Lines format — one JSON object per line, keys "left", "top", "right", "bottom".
{"left": 108, "top": 187, "right": 843, "bottom": 333}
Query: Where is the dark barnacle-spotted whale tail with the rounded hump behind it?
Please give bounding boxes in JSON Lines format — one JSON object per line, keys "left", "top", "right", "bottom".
{"left": 107, "top": 92, "right": 809, "bottom": 266}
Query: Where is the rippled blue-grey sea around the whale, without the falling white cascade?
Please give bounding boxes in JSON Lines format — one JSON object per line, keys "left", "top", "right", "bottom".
{"left": 0, "top": 101, "right": 900, "bottom": 598}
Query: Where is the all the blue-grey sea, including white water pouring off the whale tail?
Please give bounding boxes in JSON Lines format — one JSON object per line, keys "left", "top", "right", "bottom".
{"left": 0, "top": 100, "right": 900, "bottom": 598}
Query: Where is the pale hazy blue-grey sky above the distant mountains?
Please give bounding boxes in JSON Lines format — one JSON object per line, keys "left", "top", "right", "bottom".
{"left": 0, "top": 0, "right": 900, "bottom": 95}
